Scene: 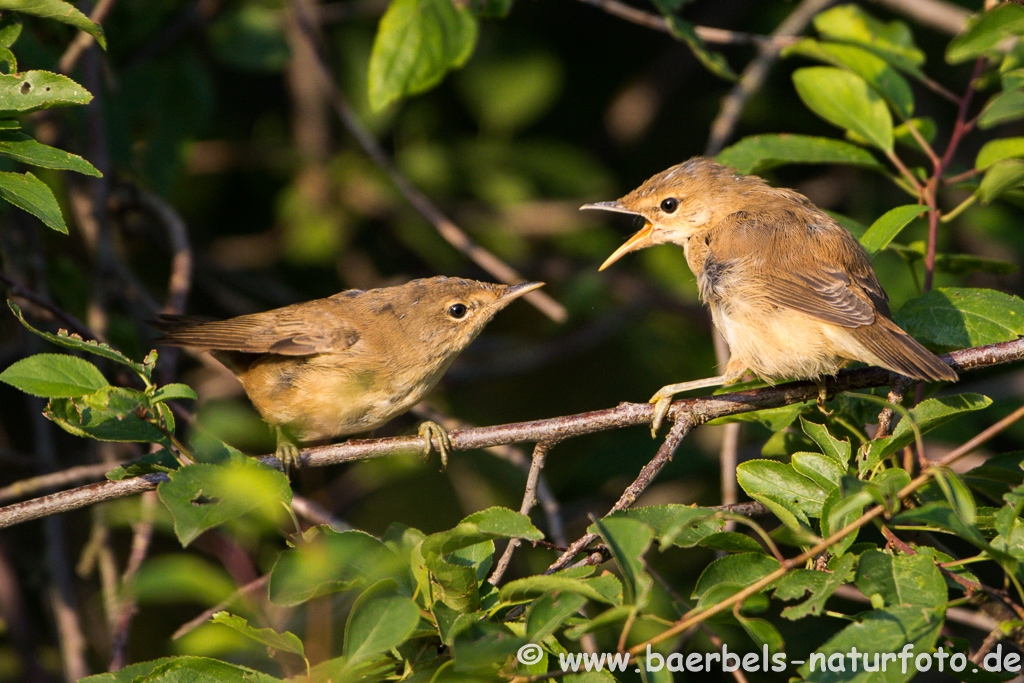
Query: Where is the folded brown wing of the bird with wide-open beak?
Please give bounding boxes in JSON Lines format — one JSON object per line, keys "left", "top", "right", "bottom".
{"left": 711, "top": 212, "right": 889, "bottom": 328}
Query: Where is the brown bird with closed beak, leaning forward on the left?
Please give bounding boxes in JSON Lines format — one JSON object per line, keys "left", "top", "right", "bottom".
{"left": 154, "top": 278, "right": 544, "bottom": 468}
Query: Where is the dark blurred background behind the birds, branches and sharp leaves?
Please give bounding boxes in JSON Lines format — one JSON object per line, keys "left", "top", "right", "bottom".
{"left": 0, "top": 0, "right": 1024, "bottom": 680}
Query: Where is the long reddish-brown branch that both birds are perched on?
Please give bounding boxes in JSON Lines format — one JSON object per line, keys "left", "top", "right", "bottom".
{"left": 0, "top": 338, "right": 1024, "bottom": 528}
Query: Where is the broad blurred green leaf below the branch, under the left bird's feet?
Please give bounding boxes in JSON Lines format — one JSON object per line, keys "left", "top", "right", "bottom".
{"left": 269, "top": 528, "right": 403, "bottom": 605}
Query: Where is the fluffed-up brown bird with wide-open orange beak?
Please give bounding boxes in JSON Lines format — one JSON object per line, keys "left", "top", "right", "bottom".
{"left": 582, "top": 157, "right": 956, "bottom": 432}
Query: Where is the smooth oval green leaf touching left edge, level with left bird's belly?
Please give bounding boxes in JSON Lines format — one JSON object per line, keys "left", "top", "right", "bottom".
{"left": 0, "top": 353, "right": 108, "bottom": 398}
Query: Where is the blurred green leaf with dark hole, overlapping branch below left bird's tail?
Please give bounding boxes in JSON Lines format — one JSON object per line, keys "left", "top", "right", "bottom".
{"left": 157, "top": 457, "right": 292, "bottom": 546}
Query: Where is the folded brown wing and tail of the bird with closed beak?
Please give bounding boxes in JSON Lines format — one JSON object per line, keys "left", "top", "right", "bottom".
{"left": 154, "top": 302, "right": 360, "bottom": 355}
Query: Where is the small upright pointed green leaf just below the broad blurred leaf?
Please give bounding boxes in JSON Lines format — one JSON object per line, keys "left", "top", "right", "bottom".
{"left": 344, "top": 579, "right": 420, "bottom": 669}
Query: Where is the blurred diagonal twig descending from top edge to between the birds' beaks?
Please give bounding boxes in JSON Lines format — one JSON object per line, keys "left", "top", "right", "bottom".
{"left": 291, "top": 3, "right": 568, "bottom": 323}
